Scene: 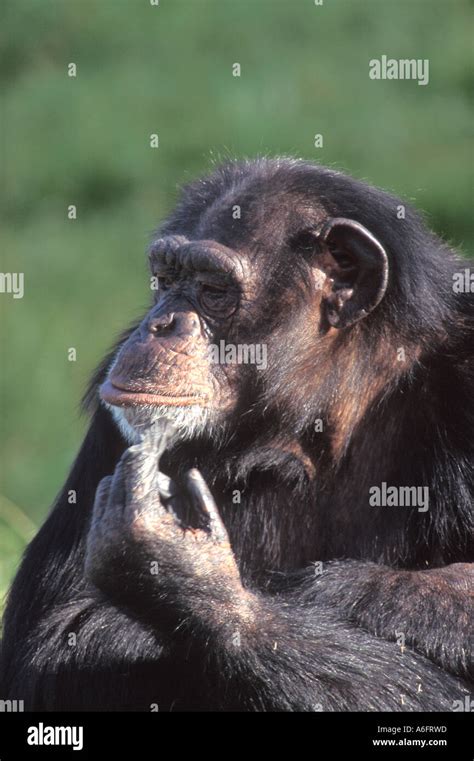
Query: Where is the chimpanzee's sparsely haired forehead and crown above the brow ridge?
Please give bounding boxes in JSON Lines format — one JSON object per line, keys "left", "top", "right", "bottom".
{"left": 156, "top": 158, "right": 360, "bottom": 258}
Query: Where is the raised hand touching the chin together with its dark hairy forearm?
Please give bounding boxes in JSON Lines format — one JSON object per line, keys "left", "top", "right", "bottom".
{"left": 86, "top": 442, "right": 465, "bottom": 711}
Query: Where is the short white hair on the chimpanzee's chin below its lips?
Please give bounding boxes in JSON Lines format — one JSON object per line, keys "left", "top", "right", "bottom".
{"left": 103, "top": 402, "right": 217, "bottom": 444}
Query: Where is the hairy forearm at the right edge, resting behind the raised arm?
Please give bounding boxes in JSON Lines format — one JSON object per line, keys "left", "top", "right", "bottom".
{"left": 293, "top": 560, "right": 474, "bottom": 679}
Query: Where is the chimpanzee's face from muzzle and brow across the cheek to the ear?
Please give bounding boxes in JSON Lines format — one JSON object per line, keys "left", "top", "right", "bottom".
{"left": 100, "top": 186, "right": 387, "bottom": 441}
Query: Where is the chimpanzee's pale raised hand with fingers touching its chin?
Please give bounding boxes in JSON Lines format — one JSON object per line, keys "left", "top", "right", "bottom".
{"left": 85, "top": 421, "right": 252, "bottom": 628}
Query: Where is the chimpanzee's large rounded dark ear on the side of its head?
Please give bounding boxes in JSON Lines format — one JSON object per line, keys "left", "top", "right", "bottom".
{"left": 317, "top": 217, "right": 388, "bottom": 328}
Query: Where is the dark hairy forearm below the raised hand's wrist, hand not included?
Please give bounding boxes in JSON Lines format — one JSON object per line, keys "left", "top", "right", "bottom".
{"left": 181, "top": 596, "right": 469, "bottom": 711}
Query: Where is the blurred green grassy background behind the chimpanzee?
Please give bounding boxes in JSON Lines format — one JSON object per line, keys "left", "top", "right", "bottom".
{"left": 0, "top": 0, "right": 474, "bottom": 616}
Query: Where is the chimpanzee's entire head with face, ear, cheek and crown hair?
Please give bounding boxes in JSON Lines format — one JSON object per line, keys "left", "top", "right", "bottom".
{"left": 101, "top": 159, "right": 448, "bottom": 448}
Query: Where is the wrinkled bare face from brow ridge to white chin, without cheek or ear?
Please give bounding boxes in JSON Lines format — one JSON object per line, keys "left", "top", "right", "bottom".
{"left": 101, "top": 236, "right": 260, "bottom": 440}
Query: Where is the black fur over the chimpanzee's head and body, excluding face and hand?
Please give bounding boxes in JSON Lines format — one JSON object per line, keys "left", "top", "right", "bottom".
{"left": 0, "top": 159, "right": 474, "bottom": 711}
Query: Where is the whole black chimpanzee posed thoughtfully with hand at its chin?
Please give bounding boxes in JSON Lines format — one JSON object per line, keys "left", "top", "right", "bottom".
{"left": 0, "top": 158, "right": 474, "bottom": 711}
